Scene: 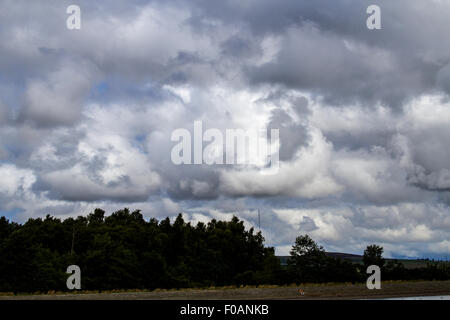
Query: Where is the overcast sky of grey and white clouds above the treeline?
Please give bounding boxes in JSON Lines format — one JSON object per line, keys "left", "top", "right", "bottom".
{"left": 0, "top": 0, "right": 450, "bottom": 259}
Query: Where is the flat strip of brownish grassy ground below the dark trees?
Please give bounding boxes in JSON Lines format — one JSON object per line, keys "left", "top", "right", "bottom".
{"left": 0, "top": 281, "right": 450, "bottom": 300}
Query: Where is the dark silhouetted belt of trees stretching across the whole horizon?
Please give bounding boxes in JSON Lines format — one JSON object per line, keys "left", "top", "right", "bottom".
{"left": 0, "top": 209, "right": 450, "bottom": 292}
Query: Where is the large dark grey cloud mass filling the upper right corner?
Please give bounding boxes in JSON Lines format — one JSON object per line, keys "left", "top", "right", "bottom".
{"left": 187, "top": 0, "right": 450, "bottom": 107}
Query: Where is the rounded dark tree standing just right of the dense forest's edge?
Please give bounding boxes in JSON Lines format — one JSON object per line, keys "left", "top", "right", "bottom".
{"left": 288, "top": 235, "right": 326, "bottom": 283}
